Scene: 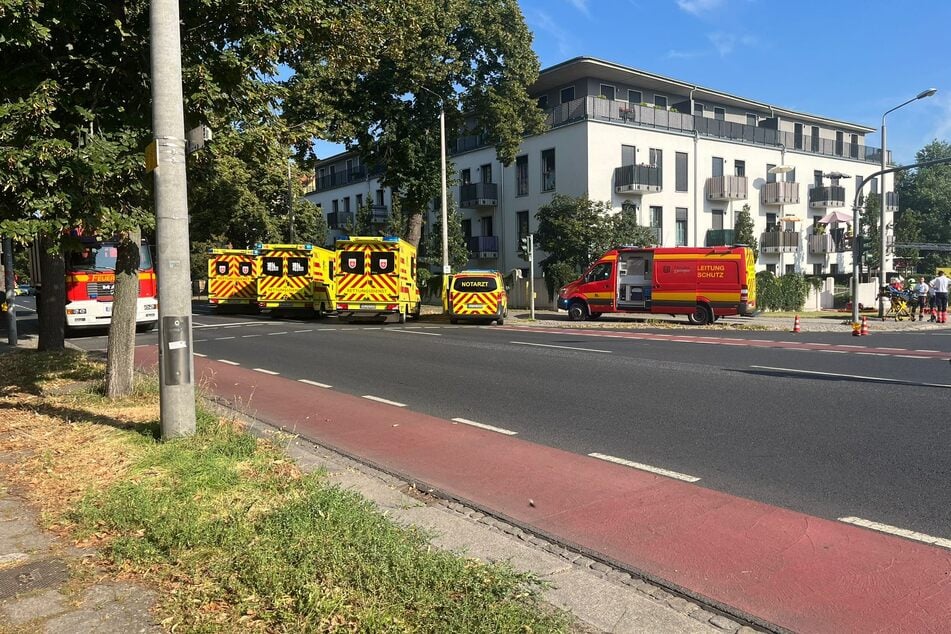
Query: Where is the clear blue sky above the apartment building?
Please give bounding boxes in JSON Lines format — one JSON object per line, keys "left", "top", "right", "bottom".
{"left": 317, "top": 0, "right": 951, "bottom": 163}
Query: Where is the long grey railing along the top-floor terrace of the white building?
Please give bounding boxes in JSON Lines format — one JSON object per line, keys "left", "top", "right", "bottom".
{"left": 546, "top": 96, "right": 891, "bottom": 164}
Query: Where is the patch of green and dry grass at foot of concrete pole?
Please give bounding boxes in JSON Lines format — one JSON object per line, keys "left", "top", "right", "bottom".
{"left": 71, "top": 402, "right": 568, "bottom": 632}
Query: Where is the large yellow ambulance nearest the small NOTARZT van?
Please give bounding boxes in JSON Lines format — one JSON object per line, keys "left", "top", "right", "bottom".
{"left": 334, "top": 236, "right": 420, "bottom": 324}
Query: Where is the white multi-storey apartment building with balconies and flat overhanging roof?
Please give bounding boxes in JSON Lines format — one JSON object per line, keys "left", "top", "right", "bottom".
{"left": 307, "top": 57, "right": 898, "bottom": 284}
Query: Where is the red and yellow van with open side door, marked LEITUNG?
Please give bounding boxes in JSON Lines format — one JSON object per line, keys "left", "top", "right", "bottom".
{"left": 558, "top": 247, "right": 756, "bottom": 325}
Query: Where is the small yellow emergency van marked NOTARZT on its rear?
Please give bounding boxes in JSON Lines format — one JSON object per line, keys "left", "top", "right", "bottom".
{"left": 443, "top": 269, "right": 509, "bottom": 326}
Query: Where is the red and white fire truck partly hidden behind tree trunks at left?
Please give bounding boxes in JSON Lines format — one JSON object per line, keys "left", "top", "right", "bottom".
{"left": 31, "top": 235, "right": 158, "bottom": 331}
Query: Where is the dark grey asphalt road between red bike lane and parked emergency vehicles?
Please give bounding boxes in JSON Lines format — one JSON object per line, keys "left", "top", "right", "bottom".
{"left": 50, "top": 304, "right": 951, "bottom": 538}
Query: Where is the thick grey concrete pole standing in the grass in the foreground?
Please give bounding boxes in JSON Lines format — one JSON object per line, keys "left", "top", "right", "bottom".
{"left": 149, "top": 0, "right": 195, "bottom": 440}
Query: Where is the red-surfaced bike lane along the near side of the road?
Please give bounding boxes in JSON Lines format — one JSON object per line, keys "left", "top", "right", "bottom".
{"left": 136, "top": 347, "right": 951, "bottom": 633}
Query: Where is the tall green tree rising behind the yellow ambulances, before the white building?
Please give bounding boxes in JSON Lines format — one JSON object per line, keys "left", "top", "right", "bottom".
{"left": 284, "top": 0, "right": 543, "bottom": 246}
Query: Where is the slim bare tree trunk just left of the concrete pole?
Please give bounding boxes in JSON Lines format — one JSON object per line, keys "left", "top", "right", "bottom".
{"left": 106, "top": 229, "right": 142, "bottom": 398}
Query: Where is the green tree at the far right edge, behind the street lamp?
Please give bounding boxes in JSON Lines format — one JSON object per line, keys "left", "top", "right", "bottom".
{"left": 895, "top": 139, "right": 951, "bottom": 274}
